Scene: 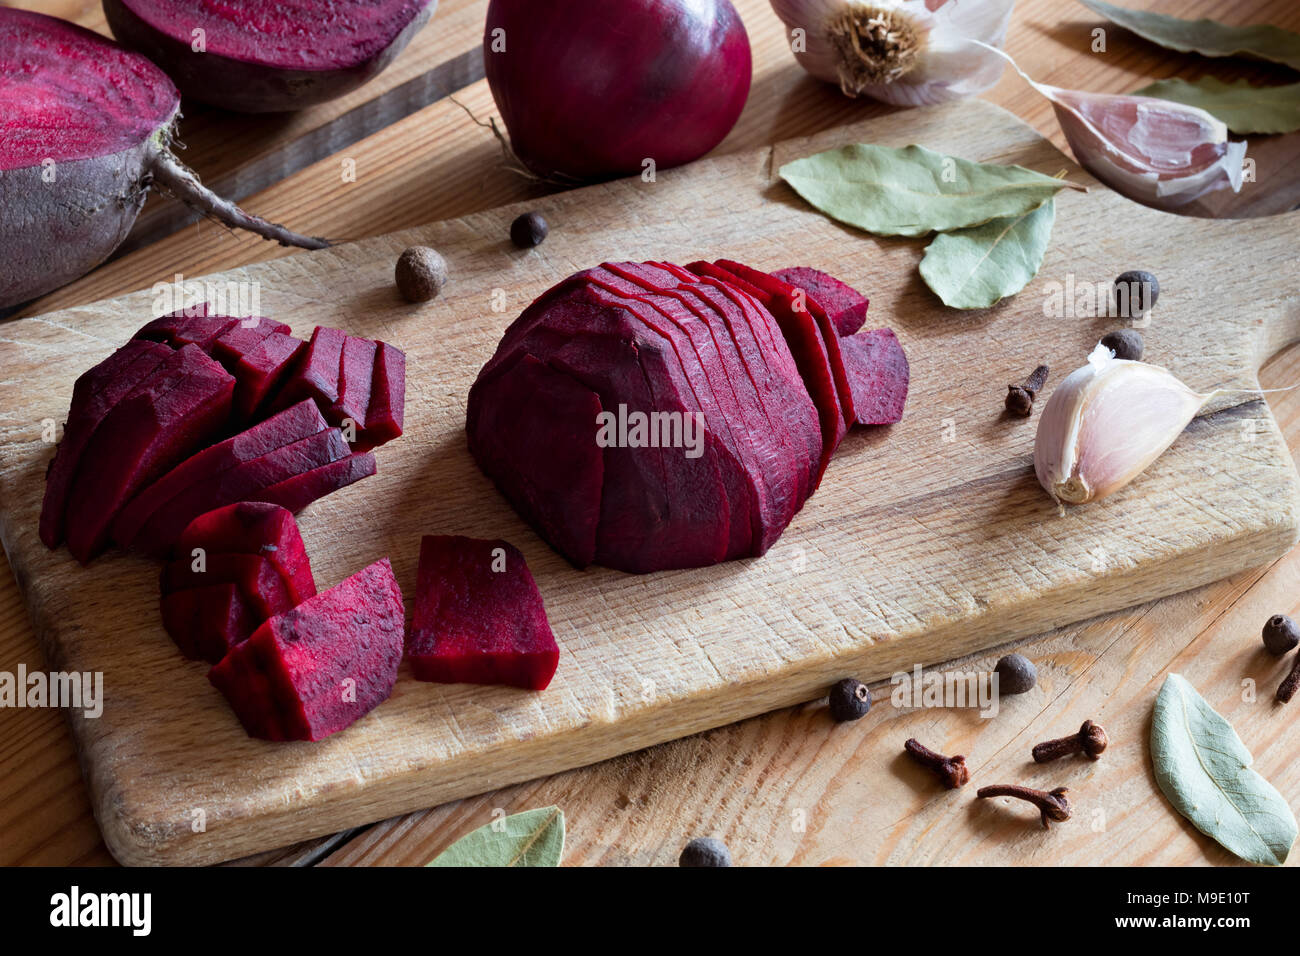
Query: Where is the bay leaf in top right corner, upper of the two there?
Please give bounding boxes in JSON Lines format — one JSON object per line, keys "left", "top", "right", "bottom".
{"left": 1079, "top": 0, "right": 1300, "bottom": 70}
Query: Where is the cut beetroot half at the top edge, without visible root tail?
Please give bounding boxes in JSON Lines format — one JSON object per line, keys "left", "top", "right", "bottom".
{"left": 104, "top": 0, "right": 437, "bottom": 113}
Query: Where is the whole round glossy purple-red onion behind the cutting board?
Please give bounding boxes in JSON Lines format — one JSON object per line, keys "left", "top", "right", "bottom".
{"left": 484, "top": 0, "right": 751, "bottom": 182}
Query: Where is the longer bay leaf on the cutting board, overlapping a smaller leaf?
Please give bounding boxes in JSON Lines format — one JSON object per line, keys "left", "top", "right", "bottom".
{"left": 780, "top": 143, "right": 1082, "bottom": 235}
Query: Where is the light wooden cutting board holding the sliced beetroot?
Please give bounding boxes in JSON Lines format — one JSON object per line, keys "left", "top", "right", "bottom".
{"left": 0, "top": 101, "right": 1300, "bottom": 864}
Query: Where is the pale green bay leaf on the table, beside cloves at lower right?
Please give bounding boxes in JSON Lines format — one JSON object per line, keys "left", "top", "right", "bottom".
{"left": 1151, "top": 674, "right": 1296, "bottom": 866}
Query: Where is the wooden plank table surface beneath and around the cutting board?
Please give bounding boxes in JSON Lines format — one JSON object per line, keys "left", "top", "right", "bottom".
{"left": 0, "top": 0, "right": 1300, "bottom": 865}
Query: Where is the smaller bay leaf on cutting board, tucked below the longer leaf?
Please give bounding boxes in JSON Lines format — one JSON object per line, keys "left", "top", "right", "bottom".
{"left": 920, "top": 199, "right": 1056, "bottom": 308}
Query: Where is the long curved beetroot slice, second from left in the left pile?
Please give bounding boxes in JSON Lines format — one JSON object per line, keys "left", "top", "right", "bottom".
{"left": 66, "top": 345, "right": 234, "bottom": 563}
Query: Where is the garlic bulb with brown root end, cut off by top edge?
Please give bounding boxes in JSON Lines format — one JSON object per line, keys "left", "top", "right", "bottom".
{"left": 771, "top": 0, "right": 1014, "bottom": 107}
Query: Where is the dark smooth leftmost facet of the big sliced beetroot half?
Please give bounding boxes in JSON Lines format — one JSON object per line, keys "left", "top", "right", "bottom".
{"left": 469, "top": 355, "right": 605, "bottom": 567}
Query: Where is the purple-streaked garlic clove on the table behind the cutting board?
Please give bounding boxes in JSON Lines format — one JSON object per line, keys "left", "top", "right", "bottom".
{"left": 1036, "top": 85, "right": 1245, "bottom": 209}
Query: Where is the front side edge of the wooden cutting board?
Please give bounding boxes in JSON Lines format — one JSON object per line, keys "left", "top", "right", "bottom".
{"left": 91, "top": 509, "right": 1300, "bottom": 866}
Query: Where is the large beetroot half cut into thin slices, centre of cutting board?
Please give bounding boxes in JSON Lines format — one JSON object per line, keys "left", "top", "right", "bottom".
{"left": 465, "top": 260, "right": 907, "bottom": 574}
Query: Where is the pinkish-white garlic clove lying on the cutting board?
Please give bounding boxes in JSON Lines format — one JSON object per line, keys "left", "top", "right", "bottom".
{"left": 1034, "top": 345, "right": 1208, "bottom": 505}
